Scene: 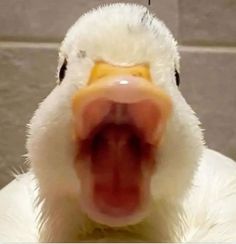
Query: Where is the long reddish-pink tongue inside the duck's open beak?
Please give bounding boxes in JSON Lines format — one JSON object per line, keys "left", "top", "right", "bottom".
{"left": 91, "top": 124, "right": 143, "bottom": 216}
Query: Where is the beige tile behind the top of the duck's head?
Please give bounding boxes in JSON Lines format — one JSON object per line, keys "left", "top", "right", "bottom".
{"left": 0, "top": 0, "right": 178, "bottom": 41}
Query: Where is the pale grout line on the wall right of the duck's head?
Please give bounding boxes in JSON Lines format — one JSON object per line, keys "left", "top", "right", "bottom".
{"left": 178, "top": 45, "right": 236, "bottom": 54}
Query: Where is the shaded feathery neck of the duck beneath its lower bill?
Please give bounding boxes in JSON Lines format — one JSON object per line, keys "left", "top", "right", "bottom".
{"left": 39, "top": 189, "right": 181, "bottom": 242}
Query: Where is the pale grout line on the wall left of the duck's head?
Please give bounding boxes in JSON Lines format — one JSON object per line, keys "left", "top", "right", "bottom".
{"left": 0, "top": 41, "right": 60, "bottom": 49}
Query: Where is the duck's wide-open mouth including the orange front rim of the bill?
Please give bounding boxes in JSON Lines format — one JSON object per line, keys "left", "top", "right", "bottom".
{"left": 73, "top": 76, "right": 171, "bottom": 225}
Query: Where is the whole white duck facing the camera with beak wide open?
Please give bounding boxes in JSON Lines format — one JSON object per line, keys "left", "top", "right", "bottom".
{"left": 0, "top": 4, "right": 236, "bottom": 242}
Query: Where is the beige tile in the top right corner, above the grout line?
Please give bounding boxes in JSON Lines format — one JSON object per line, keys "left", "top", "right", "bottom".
{"left": 179, "top": 0, "right": 236, "bottom": 46}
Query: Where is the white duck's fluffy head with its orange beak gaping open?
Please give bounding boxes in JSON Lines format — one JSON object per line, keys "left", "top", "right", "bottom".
{"left": 27, "top": 4, "right": 202, "bottom": 229}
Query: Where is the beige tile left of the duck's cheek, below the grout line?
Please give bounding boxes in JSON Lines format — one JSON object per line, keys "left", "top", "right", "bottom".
{"left": 0, "top": 45, "right": 57, "bottom": 187}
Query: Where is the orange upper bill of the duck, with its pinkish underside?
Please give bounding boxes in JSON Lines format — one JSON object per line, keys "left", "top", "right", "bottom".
{"left": 72, "top": 63, "right": 172, "bottom": 143}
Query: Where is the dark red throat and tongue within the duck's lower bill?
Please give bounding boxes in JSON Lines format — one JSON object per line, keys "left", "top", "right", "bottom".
{"left": 78, "top": 123, "right": 154, "bottom": 225}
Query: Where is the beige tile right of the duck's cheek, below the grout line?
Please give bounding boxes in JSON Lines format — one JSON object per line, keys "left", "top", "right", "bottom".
{"left": 181, "top": 48, "right": 236, "bottom": 159}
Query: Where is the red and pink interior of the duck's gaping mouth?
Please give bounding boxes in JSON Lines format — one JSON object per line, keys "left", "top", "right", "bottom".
{"left": 78, "top": 99, "right": 159, "bottom": 217}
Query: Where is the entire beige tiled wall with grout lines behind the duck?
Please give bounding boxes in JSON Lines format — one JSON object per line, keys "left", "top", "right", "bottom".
{"left": 0, "top": 0, "right": 236, "bottom": 187}
